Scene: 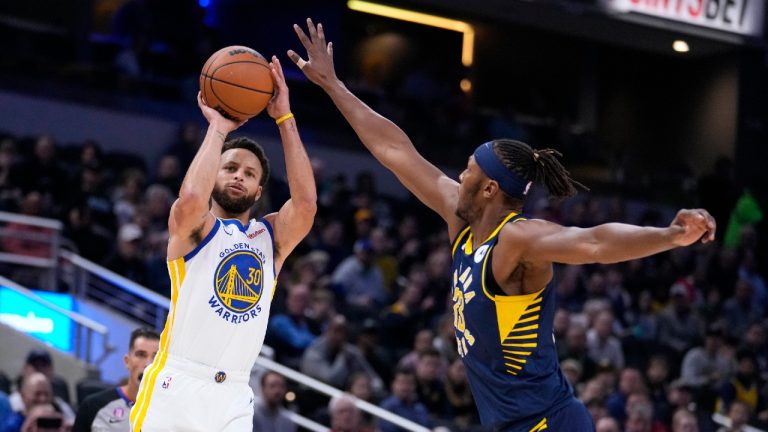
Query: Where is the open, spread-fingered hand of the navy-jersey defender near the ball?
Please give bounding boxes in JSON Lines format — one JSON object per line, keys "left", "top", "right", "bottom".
{"left": 288, "top": 18, "right": 336, "bottom": 87}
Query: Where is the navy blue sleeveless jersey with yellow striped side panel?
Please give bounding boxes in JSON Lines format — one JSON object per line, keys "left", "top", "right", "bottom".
{"left": 451, "top": 213, "right": 573, "bottom": 431}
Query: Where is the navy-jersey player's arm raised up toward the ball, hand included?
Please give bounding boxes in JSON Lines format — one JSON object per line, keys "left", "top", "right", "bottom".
{"left": 288, "top": 19, "right": 464, "bottom": 237}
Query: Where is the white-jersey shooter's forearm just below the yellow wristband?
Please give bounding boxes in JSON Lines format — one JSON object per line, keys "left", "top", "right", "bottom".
{"left": 278, "top": 118, "right": 317, "bottom": 210}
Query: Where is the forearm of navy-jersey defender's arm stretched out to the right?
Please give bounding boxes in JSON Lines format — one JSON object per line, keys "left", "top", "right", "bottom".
{"left": 592, "top": 223, "right": 675, "bottom": 264}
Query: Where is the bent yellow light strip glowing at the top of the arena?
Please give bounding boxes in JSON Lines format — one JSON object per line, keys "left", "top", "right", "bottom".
{"left": 347, "top": 0, "right": 475, "bottom": 66}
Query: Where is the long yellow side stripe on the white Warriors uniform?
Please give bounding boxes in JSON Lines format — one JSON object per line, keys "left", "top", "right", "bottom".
{"left": 130, "top": 257, "right": 186, "bottom": 432}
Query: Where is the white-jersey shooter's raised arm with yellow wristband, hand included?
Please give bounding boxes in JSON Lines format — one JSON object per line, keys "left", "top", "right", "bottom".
{"left": 266, "top": 56, "right": 317, "bottom": 271}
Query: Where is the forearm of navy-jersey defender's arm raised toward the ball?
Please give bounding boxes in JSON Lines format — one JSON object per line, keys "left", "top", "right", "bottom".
{"left": 322, "top": 80, "right": 412, "bottom": 169}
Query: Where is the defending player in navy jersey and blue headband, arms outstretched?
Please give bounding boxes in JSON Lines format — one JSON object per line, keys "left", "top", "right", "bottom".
{"left": 288, "top": 20, "right": 715, "bottom": 432}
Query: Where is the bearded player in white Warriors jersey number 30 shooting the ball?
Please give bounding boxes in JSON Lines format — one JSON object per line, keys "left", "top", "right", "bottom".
{"left": 130, "top": 57, "right": 316, "bottom": 432}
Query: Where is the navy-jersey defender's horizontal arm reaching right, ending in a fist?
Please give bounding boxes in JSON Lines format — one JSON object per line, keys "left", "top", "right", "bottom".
{"left": 502, "top": 209, "right": 716, "bottom": 264}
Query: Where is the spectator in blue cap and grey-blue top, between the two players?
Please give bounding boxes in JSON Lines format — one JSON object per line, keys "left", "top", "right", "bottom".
{"left": 331, "top": 240, "right": 387, "bottom": 314}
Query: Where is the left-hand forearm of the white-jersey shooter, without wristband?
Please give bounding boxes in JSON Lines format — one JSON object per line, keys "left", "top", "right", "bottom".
{"left": 179, "top": 123, "right": 227, "bottom": 205}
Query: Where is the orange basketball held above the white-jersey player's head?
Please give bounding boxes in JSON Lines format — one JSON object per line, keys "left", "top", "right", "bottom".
{"left": 200, "top": 45, "right": 275, "bottom": 121}
